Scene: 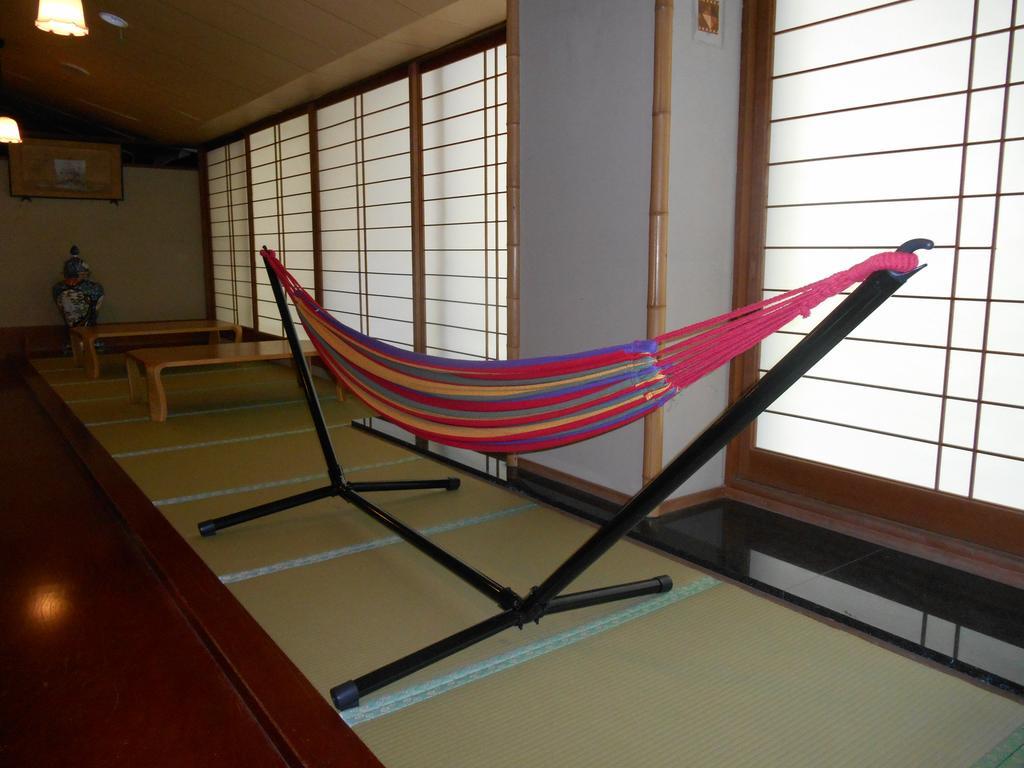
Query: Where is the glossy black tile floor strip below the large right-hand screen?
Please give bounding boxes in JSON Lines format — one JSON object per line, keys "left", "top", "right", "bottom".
{"left": 520, "top": 485, "right": 1024, "bottom": 696}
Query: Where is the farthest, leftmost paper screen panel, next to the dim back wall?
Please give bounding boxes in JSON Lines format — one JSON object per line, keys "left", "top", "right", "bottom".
{"left": 206, "top": 141, "right": 253, "bottom": 328}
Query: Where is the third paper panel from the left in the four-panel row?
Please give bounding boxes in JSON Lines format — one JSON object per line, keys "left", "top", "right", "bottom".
{"left": 316, "top": 78, "right": 413, "bottom": 349}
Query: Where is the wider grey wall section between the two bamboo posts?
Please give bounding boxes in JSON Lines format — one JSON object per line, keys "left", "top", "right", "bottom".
{"left": 519, "top": 0, "right": 654, "bottom": 489}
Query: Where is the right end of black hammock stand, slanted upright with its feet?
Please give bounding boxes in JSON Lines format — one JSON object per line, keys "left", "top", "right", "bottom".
{"left": 331, "top": 264, "right": 931, "bottom": 710}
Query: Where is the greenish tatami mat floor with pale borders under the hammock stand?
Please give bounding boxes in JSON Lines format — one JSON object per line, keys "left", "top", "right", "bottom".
{"left": 36, "top": 355, "right": 1024, "bottom": 768}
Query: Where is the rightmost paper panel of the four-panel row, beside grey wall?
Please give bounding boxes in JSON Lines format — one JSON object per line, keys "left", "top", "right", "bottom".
{"left": 422, "top": 46, "right": 508, "bottom": 359}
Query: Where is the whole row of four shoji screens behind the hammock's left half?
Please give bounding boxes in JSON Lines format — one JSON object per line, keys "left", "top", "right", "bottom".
{"left": 199, "top": 33, "right": 508, "bottom": 359}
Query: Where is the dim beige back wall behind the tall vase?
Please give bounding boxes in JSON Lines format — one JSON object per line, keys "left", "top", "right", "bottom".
{"left": 0, "top": 158, "right": 206, "bottom": 328}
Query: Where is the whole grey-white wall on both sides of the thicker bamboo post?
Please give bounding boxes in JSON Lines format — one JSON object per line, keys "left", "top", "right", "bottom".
{"left": 520, "top": 0, "right": 740, "bottom": 493}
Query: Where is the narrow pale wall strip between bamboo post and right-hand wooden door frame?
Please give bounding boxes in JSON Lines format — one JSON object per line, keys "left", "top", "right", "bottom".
{"left": 651, "top": 0, "right": 742, "bottom": 494}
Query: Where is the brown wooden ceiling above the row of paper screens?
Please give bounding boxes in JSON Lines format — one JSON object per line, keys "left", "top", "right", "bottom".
{"left": 0, "top": 0, "right": 505, "bottom": 144}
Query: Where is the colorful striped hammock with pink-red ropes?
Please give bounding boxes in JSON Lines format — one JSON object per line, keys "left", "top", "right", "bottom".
{"left": 261, "top": 248, "right": 918, "bottom": 454}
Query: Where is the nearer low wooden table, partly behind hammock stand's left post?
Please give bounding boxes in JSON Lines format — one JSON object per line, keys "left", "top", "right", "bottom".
{"left": 125, "top": 341, "right": 345, "bottom": 421}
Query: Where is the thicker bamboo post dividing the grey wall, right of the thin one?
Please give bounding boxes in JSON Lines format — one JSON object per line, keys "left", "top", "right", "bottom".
{"left": 643, "top": 0, "right": 673, "bottom": 499}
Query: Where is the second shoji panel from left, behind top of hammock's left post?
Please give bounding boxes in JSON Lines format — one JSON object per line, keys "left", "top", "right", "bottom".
{"left": 249, "top": 115, "right": 313, "bottom": 336}
